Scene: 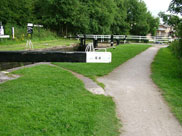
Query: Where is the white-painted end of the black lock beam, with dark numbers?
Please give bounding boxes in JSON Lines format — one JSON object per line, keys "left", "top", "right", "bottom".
{"left": 86, "top": 52, "right": 112, "bottom": 63}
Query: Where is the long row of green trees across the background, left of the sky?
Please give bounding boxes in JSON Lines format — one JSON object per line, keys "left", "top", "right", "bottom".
{"left": 0, "top": 0, "right": 159, "bottom": 35}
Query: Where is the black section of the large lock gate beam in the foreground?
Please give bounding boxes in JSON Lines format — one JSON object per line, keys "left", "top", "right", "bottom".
{"left": 0, "top": 51, "right": 86, "bottom": 62}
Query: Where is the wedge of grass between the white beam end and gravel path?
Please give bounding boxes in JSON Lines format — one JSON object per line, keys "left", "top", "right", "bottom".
{"left": 54, "top": 44, "right": 150, "bottom": 79}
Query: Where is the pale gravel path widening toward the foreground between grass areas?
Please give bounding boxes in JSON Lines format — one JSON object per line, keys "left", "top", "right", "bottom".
{"left": 98, "top": 47, "right": 182, "bottom": 136}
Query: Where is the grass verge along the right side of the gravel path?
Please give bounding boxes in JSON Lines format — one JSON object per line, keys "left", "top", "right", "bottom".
{"left": 152, "top": 48, "right": 182, "bottom": 124}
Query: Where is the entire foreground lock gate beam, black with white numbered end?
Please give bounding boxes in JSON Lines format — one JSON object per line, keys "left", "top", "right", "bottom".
{"left": 0, "top": 51, "right": 112, "bottom": 63}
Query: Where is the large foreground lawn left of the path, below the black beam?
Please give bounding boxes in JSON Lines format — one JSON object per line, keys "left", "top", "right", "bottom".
{"left": 0, "top": 65, "right": 119, "bottom": 136}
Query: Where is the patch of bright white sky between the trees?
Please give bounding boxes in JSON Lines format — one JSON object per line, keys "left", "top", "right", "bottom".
{"left": 143, "top": 0, "right": 172, "bottom": 17}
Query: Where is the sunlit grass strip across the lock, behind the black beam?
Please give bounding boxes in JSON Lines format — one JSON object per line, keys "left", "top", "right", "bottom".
{"left": 0, "top": 38, "right": 79, "bottom": 51}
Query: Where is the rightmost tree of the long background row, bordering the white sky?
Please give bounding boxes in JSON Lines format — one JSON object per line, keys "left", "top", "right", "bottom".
{"left": 127, "top": 0, "right": 159, "bottom": 35}
